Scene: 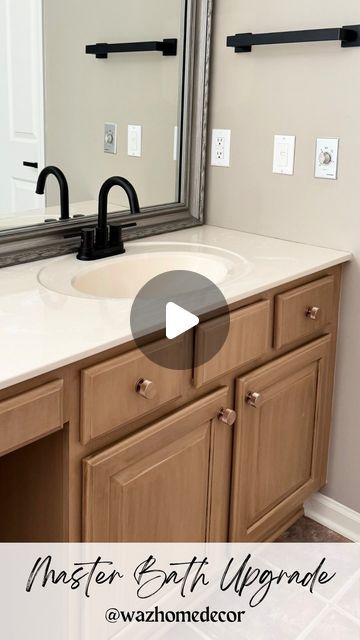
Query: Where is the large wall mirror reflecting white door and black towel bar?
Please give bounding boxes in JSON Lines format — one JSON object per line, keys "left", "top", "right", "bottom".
{"left": 0, "top": 0, "right": 212, "bottom": 266}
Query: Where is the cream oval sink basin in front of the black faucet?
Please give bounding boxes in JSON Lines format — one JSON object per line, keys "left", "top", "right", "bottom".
{"left": 39, "top": 242, "right": 249, "bottom": 299}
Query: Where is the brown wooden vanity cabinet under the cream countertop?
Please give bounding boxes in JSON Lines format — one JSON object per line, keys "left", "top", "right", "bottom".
{"left": 0, "top": 266, "right": 341, "bottom": 542}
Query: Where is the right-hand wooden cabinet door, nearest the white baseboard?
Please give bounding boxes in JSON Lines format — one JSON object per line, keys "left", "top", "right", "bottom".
{"left": 230, "top": 336, "right": 331, "bottom": 541}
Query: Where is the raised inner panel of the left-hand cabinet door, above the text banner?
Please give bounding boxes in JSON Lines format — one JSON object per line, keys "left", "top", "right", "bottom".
{"left": 110, "top": 422, "right": 211, "bottom": 542}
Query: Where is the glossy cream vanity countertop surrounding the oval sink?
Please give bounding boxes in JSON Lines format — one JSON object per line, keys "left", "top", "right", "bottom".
{"left": 0, "top": 225, "right": 351, "bottom": 389}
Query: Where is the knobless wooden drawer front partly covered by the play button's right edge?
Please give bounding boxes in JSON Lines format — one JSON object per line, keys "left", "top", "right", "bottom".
{"left": 194, "top": 300, "right": 272, "bottom": 387}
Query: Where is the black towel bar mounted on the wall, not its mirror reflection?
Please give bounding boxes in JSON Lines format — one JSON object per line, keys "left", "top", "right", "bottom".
{"left": 227, "top": 24, "right": 360, "bottom": 53}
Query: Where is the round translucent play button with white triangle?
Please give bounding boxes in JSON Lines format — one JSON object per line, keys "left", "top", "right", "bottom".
{"left": 130, "top": 265, "right": 230, "bottom": 375}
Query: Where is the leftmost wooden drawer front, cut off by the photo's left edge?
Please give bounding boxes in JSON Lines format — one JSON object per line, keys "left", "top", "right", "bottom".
{"left": 0, "top": 380, "right": 63, "bottom": 455}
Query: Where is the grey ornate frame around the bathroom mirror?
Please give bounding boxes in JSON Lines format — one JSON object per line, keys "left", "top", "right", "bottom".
{"left": 0, "top": 0, "right": 213, "bottom": 268}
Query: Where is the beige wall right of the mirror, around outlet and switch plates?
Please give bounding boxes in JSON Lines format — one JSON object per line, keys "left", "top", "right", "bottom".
{"left": 207, "top": 0, "right": 360, "bottom": 511}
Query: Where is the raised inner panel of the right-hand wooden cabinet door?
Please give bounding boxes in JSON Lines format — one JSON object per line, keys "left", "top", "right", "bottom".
{"left": 248, "top": 364, "right": 317, "bottom": 524}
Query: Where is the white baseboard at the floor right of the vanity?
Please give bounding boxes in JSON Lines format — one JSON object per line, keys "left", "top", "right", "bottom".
{"left": 304, "top": 493, "right": 360, "bottom": 542}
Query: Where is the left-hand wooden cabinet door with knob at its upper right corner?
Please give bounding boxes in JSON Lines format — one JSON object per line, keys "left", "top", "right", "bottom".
{"left": 83, "top": 388, "right": 232, "bottom": 542}
